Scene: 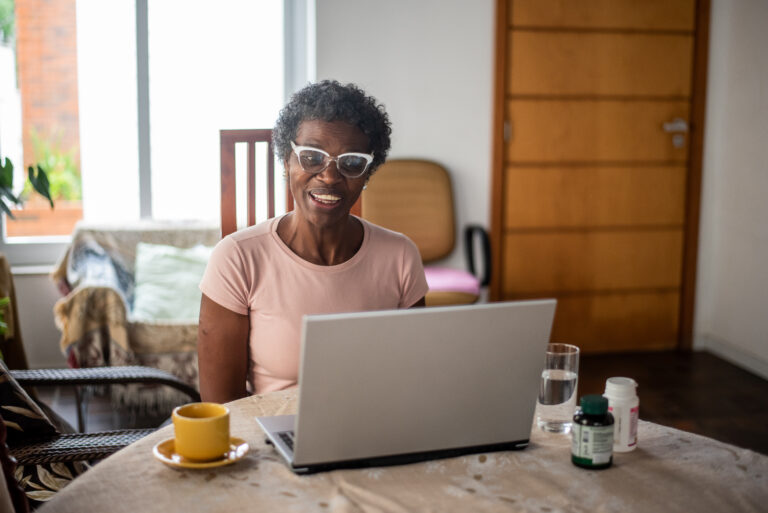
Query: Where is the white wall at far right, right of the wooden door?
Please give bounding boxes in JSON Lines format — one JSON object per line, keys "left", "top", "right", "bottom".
{"left": 695, "top": 0, "right": 768, "bottom": 378}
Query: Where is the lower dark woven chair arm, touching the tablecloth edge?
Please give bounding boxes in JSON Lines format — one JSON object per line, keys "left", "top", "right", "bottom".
{"left": 9, "top": 429, "right": 155, "bottom": 465}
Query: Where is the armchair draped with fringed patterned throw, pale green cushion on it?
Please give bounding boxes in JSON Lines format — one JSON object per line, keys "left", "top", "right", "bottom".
{"left": 42, "top": 221, "right": 219, "bottom": 416}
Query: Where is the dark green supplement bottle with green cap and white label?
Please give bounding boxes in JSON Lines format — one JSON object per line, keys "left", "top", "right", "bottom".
{"left": 571, "top": 395, "right": 613, "bottom": 470}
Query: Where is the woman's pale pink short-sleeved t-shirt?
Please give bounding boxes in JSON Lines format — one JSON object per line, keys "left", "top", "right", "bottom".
{"left": 200, "top": 217, "right": 428, "bottom": 394}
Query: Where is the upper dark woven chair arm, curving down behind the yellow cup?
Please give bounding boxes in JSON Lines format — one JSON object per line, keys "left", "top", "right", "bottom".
{"left": 11, "top": 366, "right": 200, "bottom": 402}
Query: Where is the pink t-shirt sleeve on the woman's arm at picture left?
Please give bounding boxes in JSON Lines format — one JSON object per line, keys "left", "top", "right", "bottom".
{"left": 200, "top": 237, "right": 251, "bottom": 315}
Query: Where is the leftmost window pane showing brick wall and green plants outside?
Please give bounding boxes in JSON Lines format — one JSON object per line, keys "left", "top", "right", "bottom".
{"left": 0, "top": 0, "right": 82, "bottom": 242}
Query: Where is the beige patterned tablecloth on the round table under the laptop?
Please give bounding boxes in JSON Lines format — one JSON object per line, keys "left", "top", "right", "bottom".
{"left": 40, "top": 391, "right": 768, "bottom": 513}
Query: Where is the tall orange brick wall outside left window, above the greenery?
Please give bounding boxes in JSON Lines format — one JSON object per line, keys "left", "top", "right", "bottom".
{"left": 16, "top": 0, "right": 80, "bottom": 165}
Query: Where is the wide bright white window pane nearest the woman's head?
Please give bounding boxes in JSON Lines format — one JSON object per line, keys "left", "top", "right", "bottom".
{"left": 149, "top": 0, "right": 284, "bottom": 221}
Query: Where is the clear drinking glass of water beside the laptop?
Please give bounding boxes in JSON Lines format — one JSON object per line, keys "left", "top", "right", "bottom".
{"left": 536, "top": 344, "right": 579, "bottom": 433}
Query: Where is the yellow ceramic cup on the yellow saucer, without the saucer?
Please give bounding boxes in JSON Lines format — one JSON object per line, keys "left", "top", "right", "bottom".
{"left": 173, "top": 403, "right": 229, "bottom": 461}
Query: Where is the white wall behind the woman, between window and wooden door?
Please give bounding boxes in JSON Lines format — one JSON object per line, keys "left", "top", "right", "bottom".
{"left": 316, "top": 0, "right": 495, "bottom": 265}
